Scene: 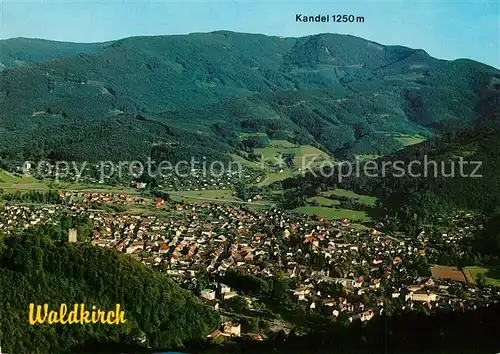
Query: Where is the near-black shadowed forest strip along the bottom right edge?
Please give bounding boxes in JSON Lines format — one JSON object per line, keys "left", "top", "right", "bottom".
{"left": 54, "top": 304, "right": 500, "bottom": 354}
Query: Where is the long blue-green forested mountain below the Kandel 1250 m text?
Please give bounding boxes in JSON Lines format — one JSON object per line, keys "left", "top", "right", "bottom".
{"left": 0, "top": 31, "right": 500, "bottom": 159}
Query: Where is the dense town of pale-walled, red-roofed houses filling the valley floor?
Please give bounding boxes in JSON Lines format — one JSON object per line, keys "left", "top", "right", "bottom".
{"left": 0, "top": 193, "right": 500, "bottom": 336}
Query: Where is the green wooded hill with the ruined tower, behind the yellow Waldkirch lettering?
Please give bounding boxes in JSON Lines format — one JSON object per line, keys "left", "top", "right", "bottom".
{"left": 0, "top": 216, "right": 219, "bottom": 354}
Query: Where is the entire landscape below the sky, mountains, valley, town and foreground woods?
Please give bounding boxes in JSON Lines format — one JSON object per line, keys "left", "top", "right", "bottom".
{"left": 0, "top": 29, "right": 500, "bottom": 354}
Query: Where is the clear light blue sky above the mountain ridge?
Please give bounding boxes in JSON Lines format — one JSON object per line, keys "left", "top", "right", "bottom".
{"left": 0, "top": 0, "right": 500, "bottom": 68}
